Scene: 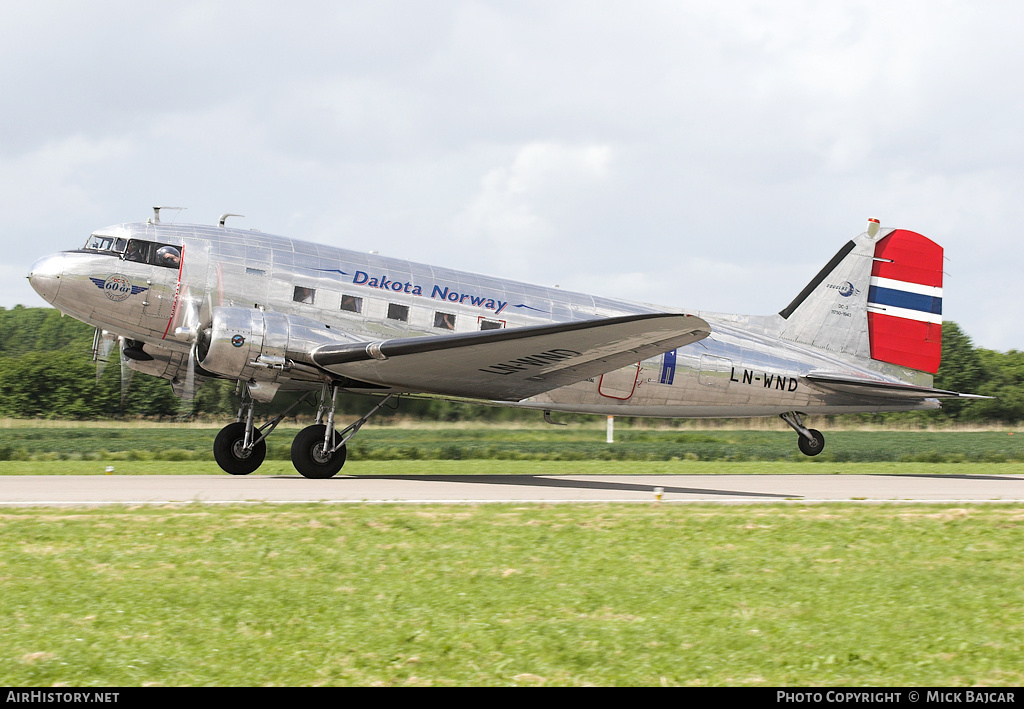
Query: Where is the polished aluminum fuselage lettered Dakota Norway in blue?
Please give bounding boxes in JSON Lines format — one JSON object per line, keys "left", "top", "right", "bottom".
{"left": 30, "top": 223, "right": 938, "bottom": 418}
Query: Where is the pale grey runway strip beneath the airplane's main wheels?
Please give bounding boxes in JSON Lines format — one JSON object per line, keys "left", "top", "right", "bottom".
{"left": 0, "top": 474, "right": 1024, "bottom": 506}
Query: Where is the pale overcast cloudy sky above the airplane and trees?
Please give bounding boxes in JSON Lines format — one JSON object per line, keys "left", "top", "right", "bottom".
{"left": 0, "top": 0, "right": 1024, "bottom": 349}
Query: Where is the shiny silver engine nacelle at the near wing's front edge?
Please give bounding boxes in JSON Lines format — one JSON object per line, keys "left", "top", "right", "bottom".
{"left": 200, "top": 307, "right": 356, "bottom": 383}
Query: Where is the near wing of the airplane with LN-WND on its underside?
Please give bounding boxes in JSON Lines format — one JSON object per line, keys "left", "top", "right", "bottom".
{"left": 312, "top": 314, "right": 711, "bottom": 401}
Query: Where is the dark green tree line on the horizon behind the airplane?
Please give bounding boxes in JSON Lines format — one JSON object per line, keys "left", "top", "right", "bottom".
{"left": 0, "top": 305, "right": 1024, "bottom": 423}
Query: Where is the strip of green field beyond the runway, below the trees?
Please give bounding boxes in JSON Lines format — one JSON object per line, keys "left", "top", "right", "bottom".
{"left": 0, "top": 425, "right": 1024, "bottom": 464}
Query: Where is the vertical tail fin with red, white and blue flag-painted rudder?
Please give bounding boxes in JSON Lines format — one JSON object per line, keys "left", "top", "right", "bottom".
{"left": 779, "top": 230, "right": 942, "bottom": 374}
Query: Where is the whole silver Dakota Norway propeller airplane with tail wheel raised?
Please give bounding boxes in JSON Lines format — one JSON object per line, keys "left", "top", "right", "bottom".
{"left": 29, "top": 207, "right": 978, "bottom": 477}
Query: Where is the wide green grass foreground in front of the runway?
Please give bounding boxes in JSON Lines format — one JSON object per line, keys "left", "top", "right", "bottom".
{"left": 0, "top": 504, "right": 1024, "bottom": 686}
